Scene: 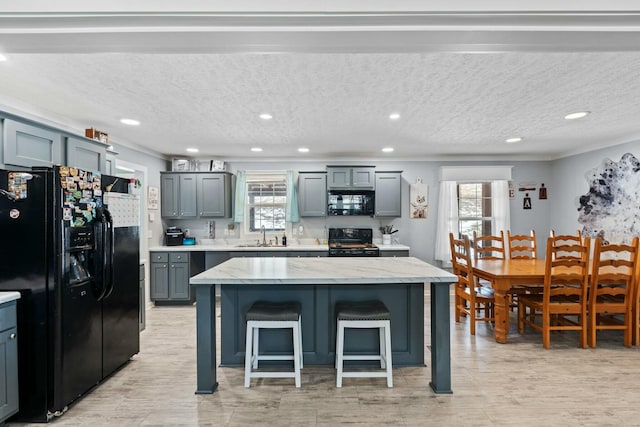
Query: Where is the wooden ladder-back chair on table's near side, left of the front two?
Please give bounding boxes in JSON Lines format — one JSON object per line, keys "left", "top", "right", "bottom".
{"left": 518, "top": 236, "right": 591, "bottom": 349}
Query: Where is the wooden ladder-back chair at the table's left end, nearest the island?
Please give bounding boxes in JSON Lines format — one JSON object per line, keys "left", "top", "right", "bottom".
{"left": 449, "top": 233, "right": 495, "bottom": 335}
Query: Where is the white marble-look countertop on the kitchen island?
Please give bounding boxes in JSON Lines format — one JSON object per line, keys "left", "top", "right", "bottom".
{"left": 190, "top": 257, "right": 458, "bottom": 285}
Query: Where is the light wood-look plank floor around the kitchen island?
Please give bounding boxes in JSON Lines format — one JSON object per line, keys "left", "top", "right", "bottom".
{"left": 9, "top": 293, "right": 640, "bottom": 426}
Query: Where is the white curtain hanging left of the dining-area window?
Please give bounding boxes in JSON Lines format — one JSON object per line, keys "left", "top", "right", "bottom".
{"left": 435, "top": 181, "right": 458, "bottom": 266}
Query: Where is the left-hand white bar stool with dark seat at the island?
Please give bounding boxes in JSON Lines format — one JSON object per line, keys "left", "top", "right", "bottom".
{"left": 244, "top": 301, "right": 303, "bottom": 388}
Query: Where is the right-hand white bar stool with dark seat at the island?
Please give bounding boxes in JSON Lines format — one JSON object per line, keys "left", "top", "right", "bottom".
{"left": 336, "top": 301, "right": 393, "bottom": 387}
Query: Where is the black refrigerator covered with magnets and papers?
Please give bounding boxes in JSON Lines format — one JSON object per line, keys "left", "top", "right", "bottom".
{"left": 0, "top": 166, "right": 140, "bottom": 422}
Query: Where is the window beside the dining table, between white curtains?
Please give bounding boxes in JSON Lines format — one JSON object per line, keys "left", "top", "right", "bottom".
{"left": 458, "top": 182, "right": 493, "bottom": 236}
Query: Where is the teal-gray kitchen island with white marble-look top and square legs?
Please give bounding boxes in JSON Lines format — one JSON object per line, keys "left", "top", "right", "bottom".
{"left": 190, "top": 257, "right": 457, "bottom": 393}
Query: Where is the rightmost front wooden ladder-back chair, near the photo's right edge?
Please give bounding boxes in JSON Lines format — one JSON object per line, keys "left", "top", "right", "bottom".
{"left": 589, "top": 237, "right": 638, "bottom": 347}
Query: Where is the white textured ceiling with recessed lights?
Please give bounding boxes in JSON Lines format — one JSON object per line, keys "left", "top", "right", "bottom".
{"left": 0, "top": 11, "right": 640, "bottom": 159}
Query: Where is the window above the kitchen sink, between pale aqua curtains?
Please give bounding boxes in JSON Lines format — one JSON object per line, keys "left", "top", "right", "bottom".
{"left": 245, "top": 172, "right": 287, "bottom": 232}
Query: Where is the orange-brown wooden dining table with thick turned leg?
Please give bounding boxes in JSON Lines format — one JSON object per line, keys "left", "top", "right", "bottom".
{"left": 473, "top": 259, "right": 545, "bottom": 343}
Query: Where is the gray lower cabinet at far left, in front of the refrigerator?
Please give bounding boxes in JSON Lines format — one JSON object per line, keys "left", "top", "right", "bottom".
{"left": 0, "top": 301, "right": 18, "bottom": 424}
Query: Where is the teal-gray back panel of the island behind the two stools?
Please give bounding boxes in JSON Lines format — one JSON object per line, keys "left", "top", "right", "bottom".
{"left": 221, "top": 283, "right": 424, "bottom": 366}
